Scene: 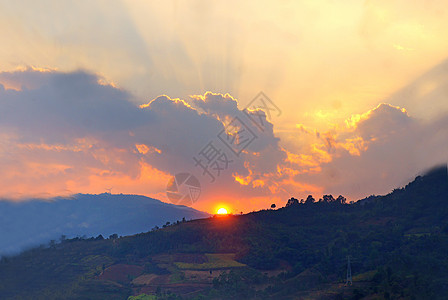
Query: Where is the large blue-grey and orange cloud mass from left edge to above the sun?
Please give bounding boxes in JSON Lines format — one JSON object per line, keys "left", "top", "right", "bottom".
{"left": 0, "top": 68, "right": 300, "bottom": 209}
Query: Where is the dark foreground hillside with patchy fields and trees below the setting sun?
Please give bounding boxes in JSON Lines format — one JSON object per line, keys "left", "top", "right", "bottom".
{"left": 0, "top": 167, "right": 448, "bottom": 299}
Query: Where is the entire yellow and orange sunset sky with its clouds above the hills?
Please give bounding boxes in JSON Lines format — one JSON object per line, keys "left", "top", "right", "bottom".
{"left": 0, "top": 0, "right": 448, "bottom": 213}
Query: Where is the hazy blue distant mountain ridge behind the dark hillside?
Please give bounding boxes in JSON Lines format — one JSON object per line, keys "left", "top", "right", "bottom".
{"left": 0, "top": 193, "right": 209, "bottom": 256}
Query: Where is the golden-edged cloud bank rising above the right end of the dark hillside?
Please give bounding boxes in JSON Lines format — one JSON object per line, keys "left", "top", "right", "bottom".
{"left": 295, "top": 103, "right": 448, "bottom": 200}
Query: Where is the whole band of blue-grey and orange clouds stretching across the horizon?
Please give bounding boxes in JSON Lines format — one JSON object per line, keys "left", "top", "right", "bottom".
{"left": 0, "top": 68, "right": 448, "bottom": 211}
